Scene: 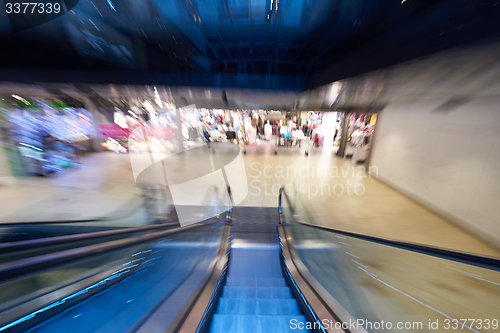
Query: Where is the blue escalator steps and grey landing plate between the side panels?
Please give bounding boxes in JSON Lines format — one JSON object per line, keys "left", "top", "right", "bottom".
{"left": 208, "top": 207, "right": 306, "bottom": 333}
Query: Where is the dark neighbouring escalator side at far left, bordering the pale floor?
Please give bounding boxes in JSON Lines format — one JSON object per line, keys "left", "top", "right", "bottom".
{"left": 0, "top": 188, "right": 180, "bottom": 264}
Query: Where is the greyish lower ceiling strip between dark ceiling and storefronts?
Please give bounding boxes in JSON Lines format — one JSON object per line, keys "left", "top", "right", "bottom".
{"left": 0, "top": 38, "right": 500, "bottom": 112}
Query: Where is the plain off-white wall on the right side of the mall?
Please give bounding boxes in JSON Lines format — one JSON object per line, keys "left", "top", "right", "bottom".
{"left": 370, "top": 97, "right": 500, "bottom": 244}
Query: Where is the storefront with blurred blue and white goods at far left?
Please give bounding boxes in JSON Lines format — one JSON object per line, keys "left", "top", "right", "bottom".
{"left": 2, "top": 95, "right": 95, "bottom": 175}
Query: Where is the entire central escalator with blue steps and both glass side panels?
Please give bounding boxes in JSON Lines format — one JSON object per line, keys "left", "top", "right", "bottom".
{"left": 0, "top": 185, "right": 500, "bottom": 333}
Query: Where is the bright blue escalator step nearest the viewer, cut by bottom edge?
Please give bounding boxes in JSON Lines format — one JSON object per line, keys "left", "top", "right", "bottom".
{"left": 210, "top": 314, "right": 309, "bottom": 333}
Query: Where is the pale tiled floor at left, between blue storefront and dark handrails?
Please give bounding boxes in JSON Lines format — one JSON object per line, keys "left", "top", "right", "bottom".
{"left": 0, "top": 153, "right": 141, "bottom": 223}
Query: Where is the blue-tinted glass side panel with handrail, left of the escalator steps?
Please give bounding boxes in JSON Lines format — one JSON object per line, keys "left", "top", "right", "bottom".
{"left": 0, "top": 185, "right": 230, "bottom": 332}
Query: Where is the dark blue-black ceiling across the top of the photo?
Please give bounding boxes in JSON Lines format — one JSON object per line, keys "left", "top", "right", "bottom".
{"left": 0, "top": 0, "right": 500, "bottom": 90}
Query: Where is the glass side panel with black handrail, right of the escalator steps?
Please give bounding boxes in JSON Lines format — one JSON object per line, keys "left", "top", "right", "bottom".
{"left": 279, "top": 188, "right": 500, "bottom": 332}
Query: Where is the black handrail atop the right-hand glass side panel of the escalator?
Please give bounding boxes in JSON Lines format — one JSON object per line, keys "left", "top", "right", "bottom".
{"left": 278, "top": 187, "right": 500, "bottom": 268}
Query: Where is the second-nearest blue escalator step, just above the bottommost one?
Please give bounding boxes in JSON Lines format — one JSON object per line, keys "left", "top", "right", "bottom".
{"left": 216, "top": 298, "right": 302, "bottom": 315}
